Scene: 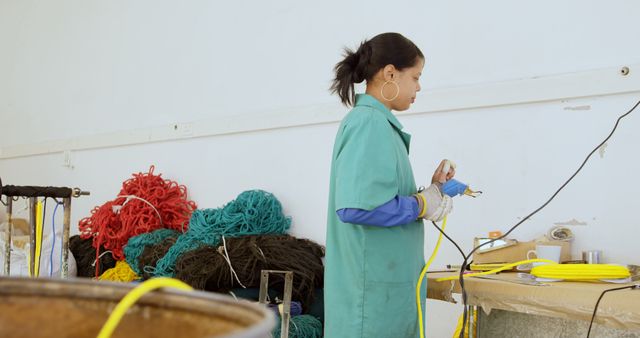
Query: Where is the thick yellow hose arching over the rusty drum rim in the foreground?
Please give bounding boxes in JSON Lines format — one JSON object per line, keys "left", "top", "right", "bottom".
{"left": 98, "top": 277, "right": 193, "bottom": 338}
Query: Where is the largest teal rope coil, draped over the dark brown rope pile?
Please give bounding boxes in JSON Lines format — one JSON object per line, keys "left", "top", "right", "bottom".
{"left": 154, "top": 190, "right": 291, "bottom": 277}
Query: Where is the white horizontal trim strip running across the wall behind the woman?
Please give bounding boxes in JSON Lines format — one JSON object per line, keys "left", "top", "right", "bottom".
{"left": 0, "top": 64, "right": 640, "bottom": 159}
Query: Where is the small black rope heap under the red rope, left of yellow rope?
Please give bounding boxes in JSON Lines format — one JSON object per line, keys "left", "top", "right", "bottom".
{"left": 69, "top": 235, "right": 116, "bottom": 278}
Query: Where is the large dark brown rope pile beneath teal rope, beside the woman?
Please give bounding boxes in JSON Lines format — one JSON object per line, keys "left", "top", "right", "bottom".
{"left": 176, "top": 235, "right": 324, "bottom": 309}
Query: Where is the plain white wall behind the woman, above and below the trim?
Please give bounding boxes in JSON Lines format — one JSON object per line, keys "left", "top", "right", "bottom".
{"left": 0, "top": 0, "right": 640, "bottom": 337}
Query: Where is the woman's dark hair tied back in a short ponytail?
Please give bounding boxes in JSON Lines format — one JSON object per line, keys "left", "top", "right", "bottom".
{"left": 330, "top": 33, "right": 424, "bottom": 106}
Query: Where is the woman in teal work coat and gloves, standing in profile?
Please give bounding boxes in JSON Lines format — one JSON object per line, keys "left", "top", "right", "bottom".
{"left": 324, "top": 33, "right": 454, "bottom": 338}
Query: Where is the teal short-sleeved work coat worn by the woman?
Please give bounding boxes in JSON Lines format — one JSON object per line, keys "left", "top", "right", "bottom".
{"left": 324, "top": 94, "right": 426, "bottom": 338}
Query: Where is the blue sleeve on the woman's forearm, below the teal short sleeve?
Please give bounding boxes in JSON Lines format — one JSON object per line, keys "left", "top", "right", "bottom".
{"left": 336, "top": 196, "right": 420, "bottom": 227}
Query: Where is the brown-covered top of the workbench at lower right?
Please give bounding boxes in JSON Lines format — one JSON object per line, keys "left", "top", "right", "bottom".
{"left": 427, "top": 272, "right": 640, "bottom": 330}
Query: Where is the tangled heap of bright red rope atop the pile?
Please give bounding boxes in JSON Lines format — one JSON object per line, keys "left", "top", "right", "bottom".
{"left": 79, "top": 166, "right": 196, "bottom": 260}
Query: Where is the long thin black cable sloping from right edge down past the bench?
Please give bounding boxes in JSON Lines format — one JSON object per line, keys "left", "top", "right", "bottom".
{"left": 458, "top": 101, "right": 640, "bottom": 338}
